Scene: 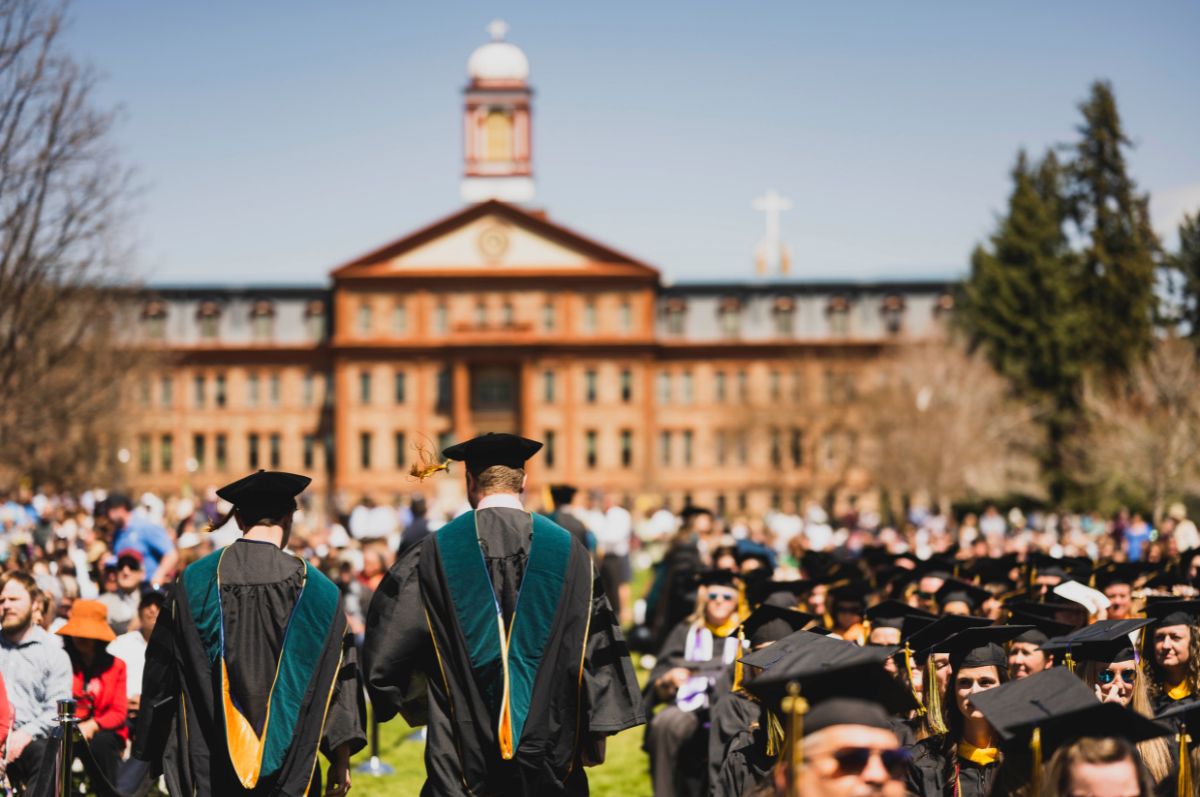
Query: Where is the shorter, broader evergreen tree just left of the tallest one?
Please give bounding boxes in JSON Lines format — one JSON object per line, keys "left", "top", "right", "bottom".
{"left": 956, "top": 151, "right": 1088, "bottom": 501}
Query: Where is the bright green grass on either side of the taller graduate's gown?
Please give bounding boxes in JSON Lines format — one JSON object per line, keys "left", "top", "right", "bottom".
{"left": 350, "top": 717, "right": 650, "bottom": 797}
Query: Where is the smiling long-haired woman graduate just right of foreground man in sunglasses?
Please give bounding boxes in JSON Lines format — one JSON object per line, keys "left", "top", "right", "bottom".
{"left": 908, "top": 625, "right": 1030, "bottom": 797}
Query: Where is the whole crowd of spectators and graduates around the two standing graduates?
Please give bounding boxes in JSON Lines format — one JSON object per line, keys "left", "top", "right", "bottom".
{"left": 0, "top": 470, "right": 1200, "bottom": 797}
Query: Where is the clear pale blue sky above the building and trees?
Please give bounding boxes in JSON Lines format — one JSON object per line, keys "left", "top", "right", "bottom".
{"left": 67, "top": 0, "right": 1200, "bottom": 284}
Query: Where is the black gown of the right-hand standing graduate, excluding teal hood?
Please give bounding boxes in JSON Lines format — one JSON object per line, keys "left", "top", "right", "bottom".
{"left": 364, "top": 508, "right": 644, "bottom": 797}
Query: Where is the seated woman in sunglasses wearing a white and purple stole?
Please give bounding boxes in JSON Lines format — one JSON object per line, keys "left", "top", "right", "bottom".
{"left": 643, "top": 570, "right": 740, "bottom": 797}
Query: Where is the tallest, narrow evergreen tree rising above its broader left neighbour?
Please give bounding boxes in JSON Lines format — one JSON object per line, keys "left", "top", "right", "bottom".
{"left": 1067, "top": 80, "right": 1159, "bottom": 376}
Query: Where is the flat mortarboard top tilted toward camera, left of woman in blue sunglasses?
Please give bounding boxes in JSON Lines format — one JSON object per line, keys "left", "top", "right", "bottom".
{"left": 971, "top": 667, "right": 1099, "bottom": 742}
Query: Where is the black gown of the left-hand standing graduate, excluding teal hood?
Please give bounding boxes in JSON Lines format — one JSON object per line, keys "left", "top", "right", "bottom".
{"left": 133, "top": 540, "right": 366, "bottom": 797}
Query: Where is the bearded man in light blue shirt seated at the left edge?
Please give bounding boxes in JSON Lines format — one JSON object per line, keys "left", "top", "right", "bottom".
{"left": 0, "top": 571, "right": 72, "bottom": 793}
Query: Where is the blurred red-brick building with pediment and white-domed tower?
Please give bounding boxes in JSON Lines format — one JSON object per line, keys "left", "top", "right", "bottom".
{"left": 126, "top": 26, "right": 950, "bottom": 510}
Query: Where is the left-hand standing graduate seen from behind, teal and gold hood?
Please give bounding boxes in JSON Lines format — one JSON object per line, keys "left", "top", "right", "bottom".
{"left": 133, "top": 471, "right": 366, "bottom": 797}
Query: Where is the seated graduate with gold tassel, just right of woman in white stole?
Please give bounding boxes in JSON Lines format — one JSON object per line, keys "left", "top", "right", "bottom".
{"left": 708, "top": 604, "right": 820, "bottom": 797}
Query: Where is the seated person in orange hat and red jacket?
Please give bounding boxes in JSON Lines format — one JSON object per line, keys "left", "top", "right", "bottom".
{"left": 58, "top": 600, "right": 130, "bottom": 784}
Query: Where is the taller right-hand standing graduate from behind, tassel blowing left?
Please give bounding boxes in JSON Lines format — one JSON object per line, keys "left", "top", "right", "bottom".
{"left": 364, "top": 435, "right": 644, "bottom": 797}
